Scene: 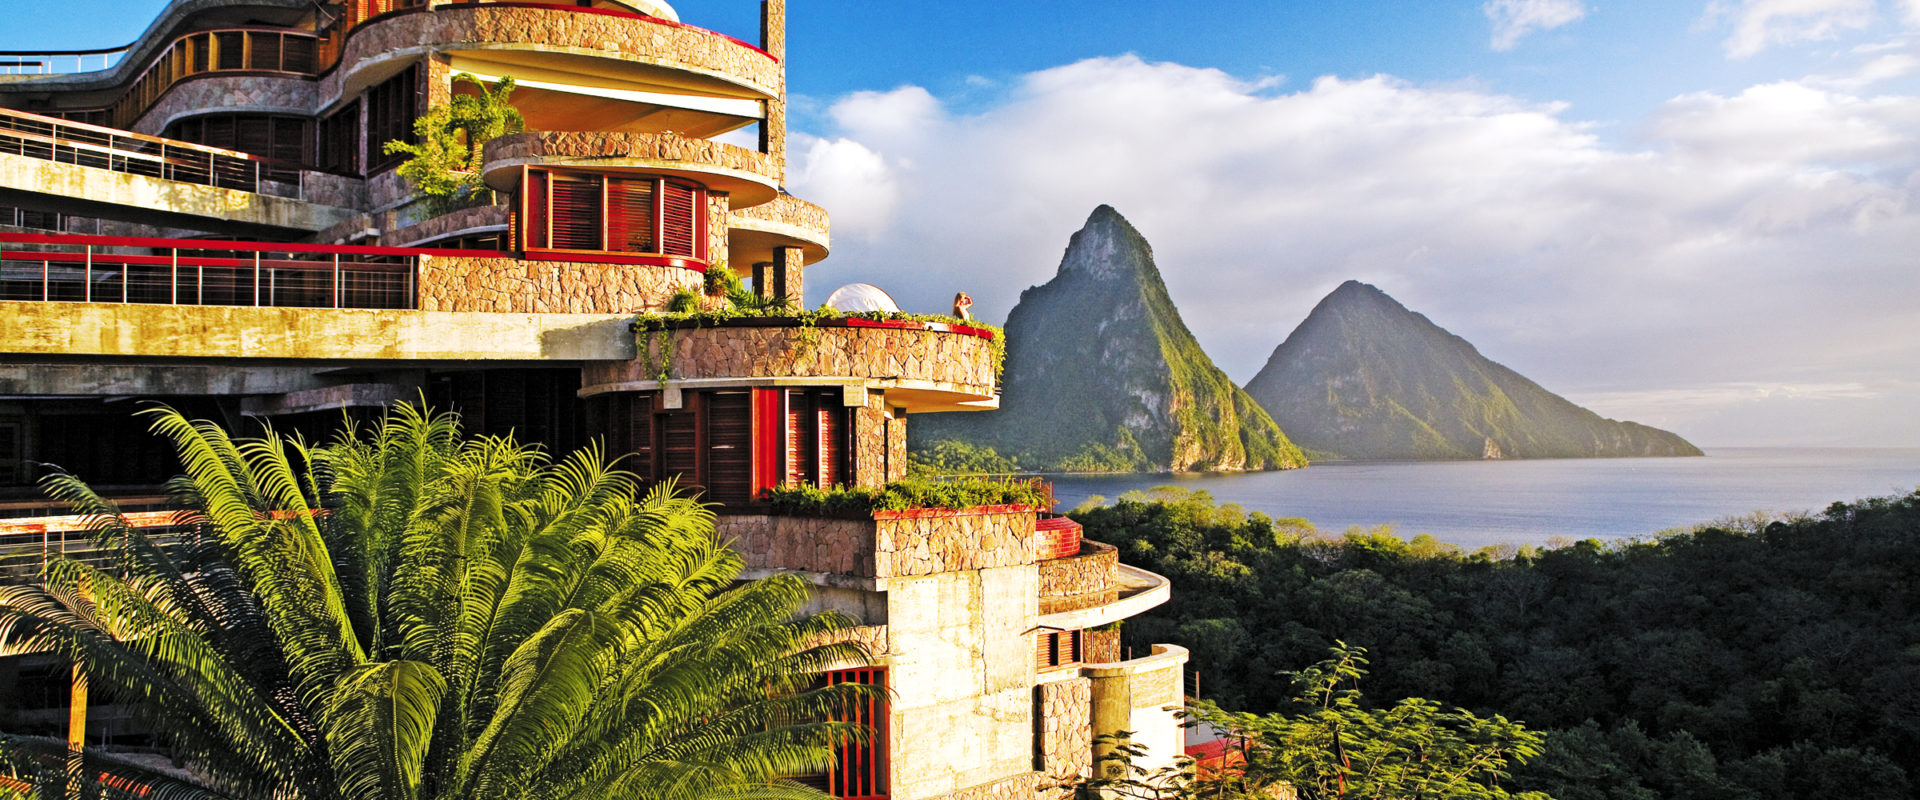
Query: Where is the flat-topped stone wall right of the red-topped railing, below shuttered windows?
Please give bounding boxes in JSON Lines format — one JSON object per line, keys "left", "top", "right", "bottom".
{"left": 420, "top": 255, "right": 703, "bottom": 315}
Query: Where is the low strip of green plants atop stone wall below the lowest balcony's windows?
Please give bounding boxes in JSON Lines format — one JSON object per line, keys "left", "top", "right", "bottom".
{"left": 766, "top": 478, "right": 1052, "bottom": 516}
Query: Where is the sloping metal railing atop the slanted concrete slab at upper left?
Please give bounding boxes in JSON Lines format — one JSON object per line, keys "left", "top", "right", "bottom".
{"left": 0, "top": 109, "right": 301, "bottom": 198}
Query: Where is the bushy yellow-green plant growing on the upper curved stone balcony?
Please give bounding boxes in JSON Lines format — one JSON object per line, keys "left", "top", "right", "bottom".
{"left": 384, "top": 73, "right": 526, "bottom": 217}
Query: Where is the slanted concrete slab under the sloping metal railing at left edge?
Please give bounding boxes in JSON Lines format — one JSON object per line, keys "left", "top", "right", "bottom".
{"left": 0, "top": 153, "right": 353, "bottom": 232}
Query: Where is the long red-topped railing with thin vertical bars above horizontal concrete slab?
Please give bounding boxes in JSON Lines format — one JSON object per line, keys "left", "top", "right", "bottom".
{"left": 0, "top": 234, "right": 435, "bottom": 309}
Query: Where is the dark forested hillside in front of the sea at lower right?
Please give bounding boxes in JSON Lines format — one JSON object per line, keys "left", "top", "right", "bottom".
{"left": 1073, "top": 489, "right": 1920, "bottom": 800}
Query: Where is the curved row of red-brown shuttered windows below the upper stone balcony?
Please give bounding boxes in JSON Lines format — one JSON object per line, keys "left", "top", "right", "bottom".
{"left": 520, "top": 169, "right": 707, "bottom": 259}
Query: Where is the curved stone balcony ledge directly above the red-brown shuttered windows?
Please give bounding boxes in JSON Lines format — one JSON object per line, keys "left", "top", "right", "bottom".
{"left": 482, "top": 130, "right": 780, "bottom": 209}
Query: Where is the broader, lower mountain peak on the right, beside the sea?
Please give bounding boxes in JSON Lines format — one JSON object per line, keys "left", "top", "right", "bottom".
{"left": 1246, "top": 280, "right": 1701, "bottom": 459}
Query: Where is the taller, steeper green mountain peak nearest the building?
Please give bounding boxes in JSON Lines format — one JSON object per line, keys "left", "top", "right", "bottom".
{"left": 908, "top": 205, "right": 1306, "bottom": 472}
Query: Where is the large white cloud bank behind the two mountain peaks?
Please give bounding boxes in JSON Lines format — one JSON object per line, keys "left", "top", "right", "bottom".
{"left": 793, "top": 56, "right": 1920, "bottom": 443}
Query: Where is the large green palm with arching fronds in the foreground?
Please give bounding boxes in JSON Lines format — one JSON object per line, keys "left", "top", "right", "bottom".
{"left": 0, "top": 405, "right": 866, "bottom": 800}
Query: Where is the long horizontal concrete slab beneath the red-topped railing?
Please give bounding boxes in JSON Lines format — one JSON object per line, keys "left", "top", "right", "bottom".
{"left": 0, "top": 301, "right": 636, "bottom": 361}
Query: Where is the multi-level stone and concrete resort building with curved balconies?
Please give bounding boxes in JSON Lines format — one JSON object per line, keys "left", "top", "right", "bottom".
{"left": 0, "top": 0, "right": 1187, "bottom": 800}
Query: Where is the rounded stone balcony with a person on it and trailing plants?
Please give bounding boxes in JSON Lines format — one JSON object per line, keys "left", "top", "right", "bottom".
{"left": 582, "top": 317, "right": 998, "bottom": 412}
